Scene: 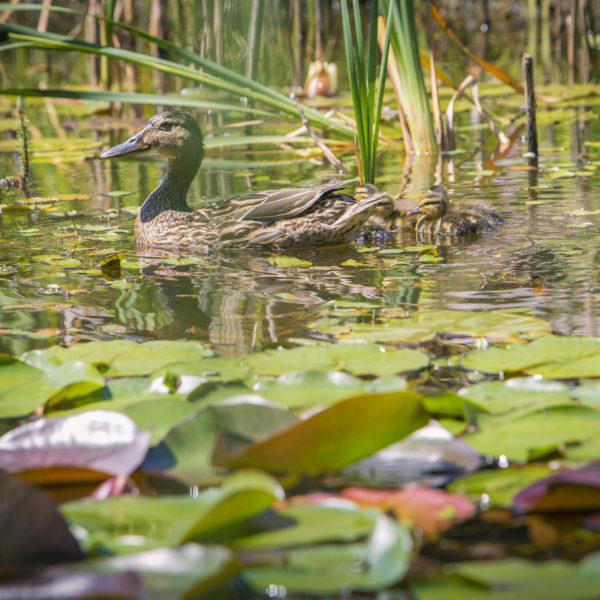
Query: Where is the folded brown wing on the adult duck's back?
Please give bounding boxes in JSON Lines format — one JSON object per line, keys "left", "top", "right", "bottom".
{"left": 231, "top": 179, "right": 356, "bottom": 223}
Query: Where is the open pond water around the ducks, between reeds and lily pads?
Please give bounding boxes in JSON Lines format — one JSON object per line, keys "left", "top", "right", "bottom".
{"left": 0, "top": 100, "right": 600, "bottom": 356}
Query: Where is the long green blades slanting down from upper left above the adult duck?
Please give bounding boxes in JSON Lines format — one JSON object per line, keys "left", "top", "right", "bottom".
{"left": 0, "top": 3, "right": 354, "bottom": 139}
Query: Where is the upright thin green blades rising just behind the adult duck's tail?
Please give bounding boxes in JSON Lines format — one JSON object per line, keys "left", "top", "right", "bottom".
{"left": 341, "top": 0, "right": 395, "bottom": 183}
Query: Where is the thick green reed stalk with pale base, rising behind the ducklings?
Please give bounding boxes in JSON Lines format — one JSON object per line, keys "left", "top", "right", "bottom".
{"left": 381, "top": 0, "right": 437, "bottom": 154}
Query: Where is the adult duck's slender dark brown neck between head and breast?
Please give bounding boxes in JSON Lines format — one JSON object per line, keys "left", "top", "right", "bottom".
{"left": 138, "top": 156, "right": 202, "bottom": 223}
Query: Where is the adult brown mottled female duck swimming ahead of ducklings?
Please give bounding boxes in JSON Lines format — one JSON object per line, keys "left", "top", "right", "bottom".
{"left": 100, "top": 110, "right": 384, "bottom": 249}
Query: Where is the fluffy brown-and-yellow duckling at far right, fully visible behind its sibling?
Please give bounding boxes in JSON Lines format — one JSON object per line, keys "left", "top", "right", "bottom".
{"left": 408, "top": 185, "right": 504, "bottom": 236}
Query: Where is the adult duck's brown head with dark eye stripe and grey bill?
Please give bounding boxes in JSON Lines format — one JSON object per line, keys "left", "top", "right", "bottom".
{"left": 100, "top": 110, "right": 204, "bottom": 160}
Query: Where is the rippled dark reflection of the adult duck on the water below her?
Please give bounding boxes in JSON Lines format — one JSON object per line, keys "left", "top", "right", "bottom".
{"left": 129, "top": 248, "right": 400, "bottom": 357}
